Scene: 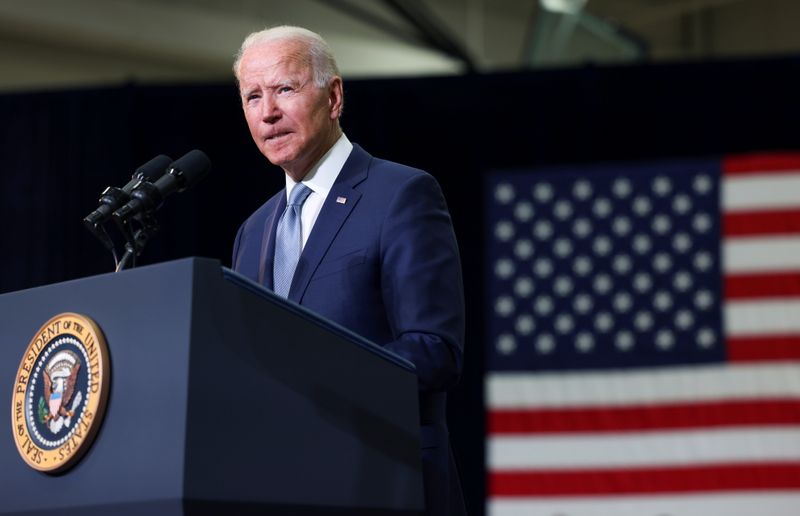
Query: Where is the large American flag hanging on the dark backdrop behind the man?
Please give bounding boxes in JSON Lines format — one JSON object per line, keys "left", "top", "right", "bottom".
{"left": 486, "top": 154, "right": 800, "bottom": 516}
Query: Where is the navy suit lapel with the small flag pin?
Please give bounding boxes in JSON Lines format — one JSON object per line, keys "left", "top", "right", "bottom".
{"left": 290, "top": 145, "right": 372, "bottom": 303}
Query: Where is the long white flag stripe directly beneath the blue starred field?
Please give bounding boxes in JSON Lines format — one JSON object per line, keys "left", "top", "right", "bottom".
{"left": 486, "top": 363, "right": 800, "bottom": 409}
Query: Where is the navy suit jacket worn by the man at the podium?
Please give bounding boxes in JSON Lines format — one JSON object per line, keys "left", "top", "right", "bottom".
{"left": 233, "top": 145, "right": 466, "bottom": 516}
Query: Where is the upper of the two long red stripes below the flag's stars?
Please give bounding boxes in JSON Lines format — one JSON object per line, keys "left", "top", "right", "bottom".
{"left": 487, "top": 399, "right": 800, "bottom": 434}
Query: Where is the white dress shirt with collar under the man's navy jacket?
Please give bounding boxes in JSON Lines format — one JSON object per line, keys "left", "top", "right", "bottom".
{"left": 286, "top": 133, "right": 353, "bottom": 248}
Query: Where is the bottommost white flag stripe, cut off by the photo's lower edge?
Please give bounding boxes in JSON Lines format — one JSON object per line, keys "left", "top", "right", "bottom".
{"left": 488, "top": 491, "right": 800, "bottom": 516}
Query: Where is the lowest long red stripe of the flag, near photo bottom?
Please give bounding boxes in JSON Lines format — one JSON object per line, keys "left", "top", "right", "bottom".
{"left": 488, "top": 462, "right": 800, "bottom": 497}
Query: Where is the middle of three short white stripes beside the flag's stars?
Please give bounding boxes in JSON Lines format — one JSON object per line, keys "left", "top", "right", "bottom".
{"left": 722, "top": 237, "right": 800, "bottom": 274}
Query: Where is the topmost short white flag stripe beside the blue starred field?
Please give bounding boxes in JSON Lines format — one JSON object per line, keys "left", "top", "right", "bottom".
{"left": 721, "top": 172, "right": 800, "bottom": 212}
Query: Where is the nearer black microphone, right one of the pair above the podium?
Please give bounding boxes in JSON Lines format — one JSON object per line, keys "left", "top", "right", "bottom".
{"left": 113, "top": 149, "right": 211, "bottom": 224}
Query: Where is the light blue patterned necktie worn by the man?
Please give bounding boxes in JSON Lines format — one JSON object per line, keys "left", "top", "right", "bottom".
{"left": 272, "top": 183, "right": 311, "bottom": 297}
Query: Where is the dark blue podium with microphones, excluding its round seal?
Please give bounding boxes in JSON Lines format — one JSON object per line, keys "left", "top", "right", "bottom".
{"left": 0, "top": 258, "right": 424, "bottom": 516}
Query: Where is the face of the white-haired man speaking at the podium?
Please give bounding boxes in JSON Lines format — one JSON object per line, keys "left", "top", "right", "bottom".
{"left": 234, "top": 41, "right": 342, "bottom": 181}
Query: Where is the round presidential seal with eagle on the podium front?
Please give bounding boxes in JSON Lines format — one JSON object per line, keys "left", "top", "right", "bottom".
{"left": 11, "top": 313, "right": 110, "bottom": 473}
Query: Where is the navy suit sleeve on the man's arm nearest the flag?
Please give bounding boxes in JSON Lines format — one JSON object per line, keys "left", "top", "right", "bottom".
{"left": 380, "top": 174, "right": 464, "bottom": 391}
